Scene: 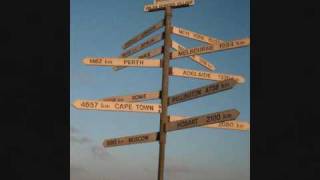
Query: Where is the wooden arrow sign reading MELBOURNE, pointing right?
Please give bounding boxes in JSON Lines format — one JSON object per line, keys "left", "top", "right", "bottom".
{"left": 171, "top": 38, "right": 250, "bottom": 59}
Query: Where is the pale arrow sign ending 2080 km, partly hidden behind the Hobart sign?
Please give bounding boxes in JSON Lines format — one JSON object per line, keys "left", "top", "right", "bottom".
{"left": 169, "top": 116, "right": 250, "bottom": 131}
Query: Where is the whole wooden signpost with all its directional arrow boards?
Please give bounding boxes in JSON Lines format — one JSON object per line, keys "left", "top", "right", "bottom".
{"left": 73, "top": 0, "right": 250, "bottom": 180}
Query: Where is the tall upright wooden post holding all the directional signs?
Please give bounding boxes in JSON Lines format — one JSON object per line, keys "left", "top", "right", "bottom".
{"left": 158, "top": 7, "right": 172, "bottom": 180}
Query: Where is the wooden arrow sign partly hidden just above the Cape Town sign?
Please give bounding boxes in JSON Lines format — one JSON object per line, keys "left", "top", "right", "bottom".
{"left": 99, "top": 91, "right": 160, "bottom": 102}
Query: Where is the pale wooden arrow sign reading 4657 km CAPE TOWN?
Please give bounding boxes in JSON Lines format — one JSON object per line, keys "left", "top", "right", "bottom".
{"left": 73, "top": 100, "right": 161, "bottom": 113}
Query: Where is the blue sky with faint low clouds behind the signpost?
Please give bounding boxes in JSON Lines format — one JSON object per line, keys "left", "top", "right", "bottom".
{"left": 70, "top": 0, "right": 250, "bottom": 180}
